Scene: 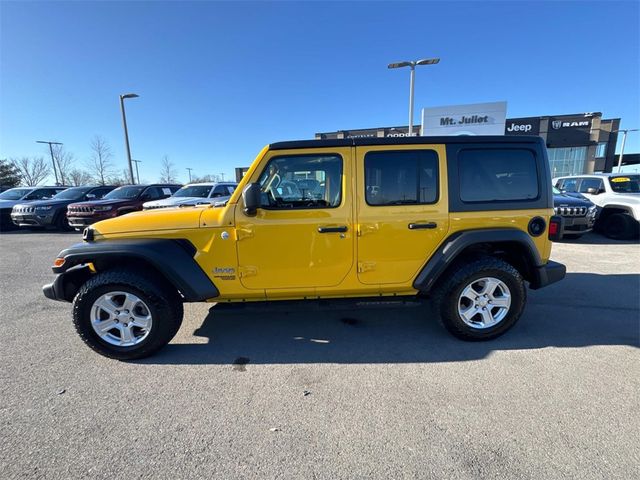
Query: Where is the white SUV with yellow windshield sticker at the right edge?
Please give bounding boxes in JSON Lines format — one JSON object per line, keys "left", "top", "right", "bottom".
{"left": 553, "top": 173, "right": 640, "bottom": 240}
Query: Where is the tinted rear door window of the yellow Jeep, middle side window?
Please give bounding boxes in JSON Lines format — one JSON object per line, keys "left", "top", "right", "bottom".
{"left": 364, "top": 150, "right": 438, "bottom": 206}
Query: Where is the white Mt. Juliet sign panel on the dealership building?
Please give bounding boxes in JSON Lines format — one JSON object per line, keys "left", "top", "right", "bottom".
{"left": 422, "top": 102, "right": 507, "bottom": 136}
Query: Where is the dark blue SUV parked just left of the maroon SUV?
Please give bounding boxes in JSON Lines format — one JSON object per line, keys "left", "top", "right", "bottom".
{"left": 11, "top": 186, "right": 116, "bottom": 230}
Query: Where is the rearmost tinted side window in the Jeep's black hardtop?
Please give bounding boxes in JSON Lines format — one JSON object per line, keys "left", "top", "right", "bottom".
{"left": 458, "top": 149, "right": 539, "bottom": 203}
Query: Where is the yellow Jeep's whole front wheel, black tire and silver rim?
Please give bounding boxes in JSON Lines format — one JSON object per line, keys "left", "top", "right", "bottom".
{"left": 73, "top": 269, "right": 183, "bottom": 360}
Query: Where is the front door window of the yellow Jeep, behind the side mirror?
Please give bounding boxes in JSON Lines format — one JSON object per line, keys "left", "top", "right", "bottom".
{"left": 259, "top": 154, "right": 342, "bottom": 209}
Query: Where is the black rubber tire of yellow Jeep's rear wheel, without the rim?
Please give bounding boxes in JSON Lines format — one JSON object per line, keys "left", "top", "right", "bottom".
{"left": 433, "top": 256, "right": 527, "bottom": 341}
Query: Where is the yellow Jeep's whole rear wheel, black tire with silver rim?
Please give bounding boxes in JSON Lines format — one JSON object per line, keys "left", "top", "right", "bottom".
{"left": 434, "top": 257, "right": 526, "bottom": 340}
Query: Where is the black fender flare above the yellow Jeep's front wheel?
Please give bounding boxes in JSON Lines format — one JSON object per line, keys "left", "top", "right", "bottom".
{"left": 45, "top": 238, "right": 220, "bottom": 302}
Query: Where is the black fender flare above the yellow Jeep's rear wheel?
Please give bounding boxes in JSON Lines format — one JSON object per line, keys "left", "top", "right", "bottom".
{"left": 413, "top": 228, "right": 543, "bottom": 293}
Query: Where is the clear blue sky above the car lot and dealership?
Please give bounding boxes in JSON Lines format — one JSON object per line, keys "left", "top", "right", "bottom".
{"left": 0, "top": 0, "right": 640, "bottom": 182}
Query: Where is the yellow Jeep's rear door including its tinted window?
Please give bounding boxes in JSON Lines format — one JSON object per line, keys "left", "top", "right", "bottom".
{"left": 356, "top": 145, "right": 449, "bottom": 285}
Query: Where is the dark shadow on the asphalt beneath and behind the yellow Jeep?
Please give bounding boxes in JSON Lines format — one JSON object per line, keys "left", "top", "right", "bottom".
{"left": 141, "top": 273, "right": 640, "bottom": 369}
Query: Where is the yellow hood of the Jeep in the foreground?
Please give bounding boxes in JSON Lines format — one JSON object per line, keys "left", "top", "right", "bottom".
{"left": 92, "top": 207, "right": 210, "bottom": 236}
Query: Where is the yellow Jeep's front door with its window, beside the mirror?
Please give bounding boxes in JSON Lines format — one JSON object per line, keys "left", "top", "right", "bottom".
{"left": 236, "top": 147, "right": 354, "bottom": 297}
